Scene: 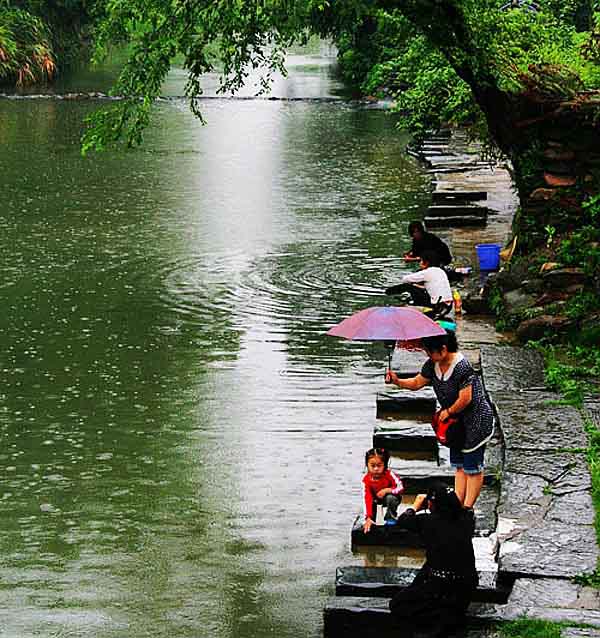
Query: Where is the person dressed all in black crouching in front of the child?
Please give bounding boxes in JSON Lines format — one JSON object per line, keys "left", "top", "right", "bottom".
{"left": 390, "top": 482, "right": 478, "bottom": 638}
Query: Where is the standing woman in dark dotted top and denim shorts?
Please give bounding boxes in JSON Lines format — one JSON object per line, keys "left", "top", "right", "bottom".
{"left": 386, "top": 331, "right": 494, "bottom": 509}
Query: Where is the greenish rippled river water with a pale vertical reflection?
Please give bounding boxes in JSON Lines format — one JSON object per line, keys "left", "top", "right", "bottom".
{"left": 0, "top": 47, "right": 429, "bottom": 638}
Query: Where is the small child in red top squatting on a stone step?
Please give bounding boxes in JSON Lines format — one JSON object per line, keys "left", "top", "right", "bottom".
{"left": 362, "top": 447, "right": 404, "bottom": 534}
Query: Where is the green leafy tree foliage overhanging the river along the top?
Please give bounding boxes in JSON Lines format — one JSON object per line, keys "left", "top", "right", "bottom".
{"left": 73, "top": 0, "right": 600, "bottom": 152}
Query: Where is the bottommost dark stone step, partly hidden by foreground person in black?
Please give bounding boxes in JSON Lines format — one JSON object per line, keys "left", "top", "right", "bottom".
{"left": 323, "top": 596, "right": 497, "bottom": 638}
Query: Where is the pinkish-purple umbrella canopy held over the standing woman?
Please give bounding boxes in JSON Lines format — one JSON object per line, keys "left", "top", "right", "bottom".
{"left": 327, "top": 306, "right": 446, "bottom": 341}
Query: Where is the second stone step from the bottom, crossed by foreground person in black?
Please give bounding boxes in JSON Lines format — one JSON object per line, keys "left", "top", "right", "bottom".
{"left": 335, "top": 566, "right": 512, "bottom": 603}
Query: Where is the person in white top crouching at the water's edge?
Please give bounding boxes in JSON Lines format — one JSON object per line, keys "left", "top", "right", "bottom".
{"left": 385, "top": 251, "right": 452, "bottom": 316}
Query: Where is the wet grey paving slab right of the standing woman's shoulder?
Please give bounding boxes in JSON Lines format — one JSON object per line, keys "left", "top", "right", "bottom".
{"left": 481, "top": 344, "right": 546, "bottom": 399}
